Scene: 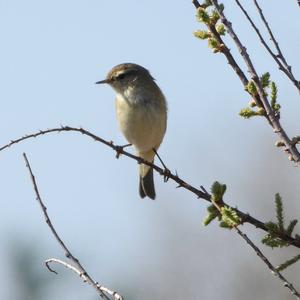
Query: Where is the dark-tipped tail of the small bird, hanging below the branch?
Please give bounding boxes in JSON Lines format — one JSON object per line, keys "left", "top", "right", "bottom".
{"left": 139, "top": 150, "right": 155, "bottom": 200}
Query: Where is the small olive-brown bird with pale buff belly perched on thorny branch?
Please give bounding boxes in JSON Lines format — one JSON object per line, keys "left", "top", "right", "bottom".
{"left": 96, "top": 63, "right": 167, "bottom": 200}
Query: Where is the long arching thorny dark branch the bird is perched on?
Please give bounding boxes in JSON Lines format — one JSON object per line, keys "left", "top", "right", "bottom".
{"left": 0, "top": 126, "right": 300, "bottom": 248}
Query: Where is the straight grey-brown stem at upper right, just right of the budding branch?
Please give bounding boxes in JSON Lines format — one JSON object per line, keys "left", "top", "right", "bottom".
{"left": 207, "top": 0, "right": 300, "bottom": 165}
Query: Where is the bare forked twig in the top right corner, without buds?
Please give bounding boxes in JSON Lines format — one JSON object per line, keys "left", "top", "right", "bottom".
{"left": 235, "top": 0, "right": 300, "bottom": 93}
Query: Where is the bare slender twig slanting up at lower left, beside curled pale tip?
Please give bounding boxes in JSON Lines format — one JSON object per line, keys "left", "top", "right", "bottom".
{"left": 23, "top": 153, "right": 122, "bottom": 300}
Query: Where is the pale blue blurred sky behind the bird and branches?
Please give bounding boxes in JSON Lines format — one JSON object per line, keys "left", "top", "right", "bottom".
{"left": 0, "top": 0, "right": 300, "bottom": 300}
